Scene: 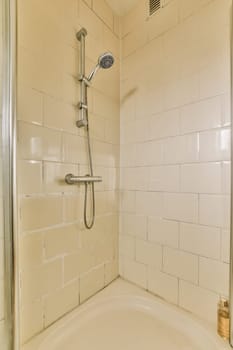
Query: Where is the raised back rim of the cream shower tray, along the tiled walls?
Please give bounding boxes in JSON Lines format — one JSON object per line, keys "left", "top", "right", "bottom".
{"left": 22, "top": 278, "right": 232, "bottom": 350}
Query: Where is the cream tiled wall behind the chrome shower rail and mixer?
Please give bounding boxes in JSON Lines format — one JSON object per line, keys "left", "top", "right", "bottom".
{"left": 18, "top": 0, "right": 120, "bottom": 343}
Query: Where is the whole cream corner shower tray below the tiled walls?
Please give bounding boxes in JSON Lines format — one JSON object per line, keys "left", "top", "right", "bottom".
{"left": 23, "top": 279, "right": 231, "bottom": 350}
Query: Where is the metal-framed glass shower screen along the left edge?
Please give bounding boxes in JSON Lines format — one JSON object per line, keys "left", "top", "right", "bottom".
{"left": 0, "top": 0, "right": 16, "bottom": 350}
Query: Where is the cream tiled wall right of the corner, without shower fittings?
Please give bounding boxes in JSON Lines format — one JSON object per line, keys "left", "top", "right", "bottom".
{"left": 119, "top": 0, "right": 231, "bottom": 322}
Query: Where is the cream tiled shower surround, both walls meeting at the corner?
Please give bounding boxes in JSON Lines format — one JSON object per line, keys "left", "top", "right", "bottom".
{"left": 17, "top": 0, "right": 231, "bottom": 343}
